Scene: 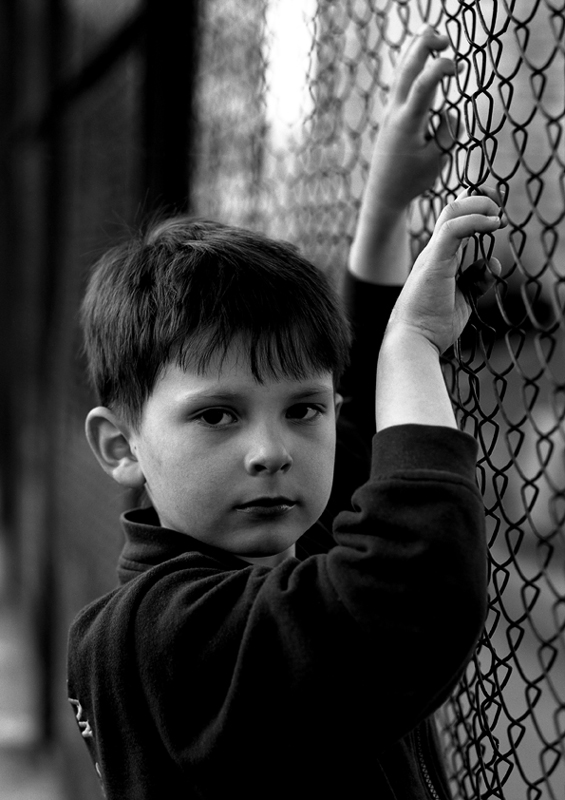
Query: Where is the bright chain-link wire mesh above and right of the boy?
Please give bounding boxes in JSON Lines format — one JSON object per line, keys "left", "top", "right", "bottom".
{"left": 193, "top": 0, "right": 565, "bottom": 800}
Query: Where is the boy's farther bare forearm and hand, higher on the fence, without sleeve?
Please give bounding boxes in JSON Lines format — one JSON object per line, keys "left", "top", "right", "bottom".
{"left": 349, "top": 27, "right": 455, "bottom": 285}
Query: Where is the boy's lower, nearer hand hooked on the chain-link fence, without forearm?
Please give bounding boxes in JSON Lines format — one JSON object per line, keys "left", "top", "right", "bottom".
{"left": 387, "top": 188, "right": 506, "bottom": 353}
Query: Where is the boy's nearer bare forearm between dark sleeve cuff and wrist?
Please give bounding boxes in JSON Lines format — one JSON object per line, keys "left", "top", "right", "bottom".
{"left": 376, "top": 329, "right": 457, "bottom": 431}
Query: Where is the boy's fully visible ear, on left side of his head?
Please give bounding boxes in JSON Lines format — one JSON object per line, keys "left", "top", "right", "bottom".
{"left": 85, "top": 406, "right": 145, "bottom": 489}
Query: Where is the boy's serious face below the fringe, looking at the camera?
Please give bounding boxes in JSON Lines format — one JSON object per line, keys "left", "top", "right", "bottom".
{"left": 124, "top": 344, "right": 336, "bottom": 563}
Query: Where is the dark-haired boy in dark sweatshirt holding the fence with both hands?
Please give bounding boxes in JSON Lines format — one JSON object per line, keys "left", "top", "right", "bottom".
{"left": 69, "top": 30, "right": 501, "bottom": 800}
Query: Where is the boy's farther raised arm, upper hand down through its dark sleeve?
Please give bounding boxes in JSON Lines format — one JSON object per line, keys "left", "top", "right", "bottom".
{"left": 334, "top": 27, "right": 455, "bottom": 443}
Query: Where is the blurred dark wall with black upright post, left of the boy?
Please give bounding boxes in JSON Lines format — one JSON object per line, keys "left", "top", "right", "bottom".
{"left": 0, "top": 0, "right": 198, "bottom": 800}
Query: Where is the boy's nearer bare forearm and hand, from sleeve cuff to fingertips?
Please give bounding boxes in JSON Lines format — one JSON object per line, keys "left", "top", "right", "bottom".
{"left": 376, "top": 190, "right": 505, "bottom": 430}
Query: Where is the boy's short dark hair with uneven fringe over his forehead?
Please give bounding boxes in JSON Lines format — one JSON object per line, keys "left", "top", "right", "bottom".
{"left": 81, "top": 212, "right": 350, "bottom": 424}
